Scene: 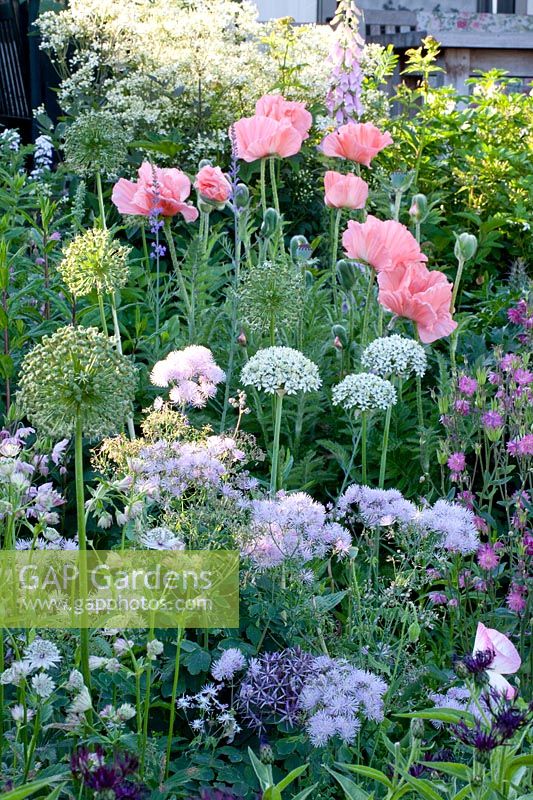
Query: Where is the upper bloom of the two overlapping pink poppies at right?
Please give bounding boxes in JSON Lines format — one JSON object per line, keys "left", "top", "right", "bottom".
{"left": 342, "top": 214, "right": 427, "bottom": 272}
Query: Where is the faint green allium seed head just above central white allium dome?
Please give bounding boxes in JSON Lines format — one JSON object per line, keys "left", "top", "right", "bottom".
{"left": 239, "top": 261, "right": 303, "bottom": 334}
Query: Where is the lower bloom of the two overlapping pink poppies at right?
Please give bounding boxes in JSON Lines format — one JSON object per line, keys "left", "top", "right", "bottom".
{"left": 378, "top": 264, "right": 457, "bottom": 344}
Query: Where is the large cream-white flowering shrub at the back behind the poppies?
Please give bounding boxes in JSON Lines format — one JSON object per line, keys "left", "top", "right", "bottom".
{"left": 37, "top": 0, "right": 333, "bottom": 133}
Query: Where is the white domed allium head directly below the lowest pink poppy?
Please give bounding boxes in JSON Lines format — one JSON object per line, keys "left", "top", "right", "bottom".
{"left": 361, "top": 333, "right": 427, "bottom": 378}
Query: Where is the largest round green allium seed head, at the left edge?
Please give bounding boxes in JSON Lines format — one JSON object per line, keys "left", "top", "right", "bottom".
{"left": 18, "top": 325, "right": 137, "bottom": 439}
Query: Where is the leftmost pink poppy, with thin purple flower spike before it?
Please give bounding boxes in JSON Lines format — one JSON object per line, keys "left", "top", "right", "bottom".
{"left": 111, "top": 161, "right": 198, "bottom": 222}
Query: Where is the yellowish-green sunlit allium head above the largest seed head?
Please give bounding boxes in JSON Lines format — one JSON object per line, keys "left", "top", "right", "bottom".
{"left": 58, "top": 228, "right": 131, "bottom": 297}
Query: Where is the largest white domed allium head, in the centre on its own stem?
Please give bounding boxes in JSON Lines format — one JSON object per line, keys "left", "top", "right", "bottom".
{"left": 241, "top": 347, "right": 322, "bottom": 394}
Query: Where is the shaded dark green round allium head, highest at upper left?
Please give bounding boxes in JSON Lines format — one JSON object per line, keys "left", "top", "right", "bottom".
{"left": 64, "top": 111, "right": 129, "bottom": 177}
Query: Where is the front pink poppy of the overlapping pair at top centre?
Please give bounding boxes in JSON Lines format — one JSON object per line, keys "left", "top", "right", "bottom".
{"left": 230, "top": 115, "right": 303, "bottom": 162}
